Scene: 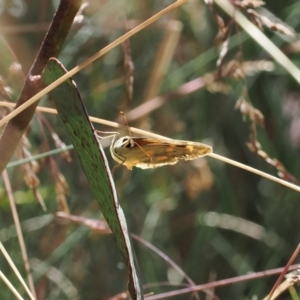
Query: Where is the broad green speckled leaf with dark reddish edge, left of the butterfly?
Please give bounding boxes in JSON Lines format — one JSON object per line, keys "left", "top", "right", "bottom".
{"left": 41, "top": 58, "right": 143, "bottom": 299}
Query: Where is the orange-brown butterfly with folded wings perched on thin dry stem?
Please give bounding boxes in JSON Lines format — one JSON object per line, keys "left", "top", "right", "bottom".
{"left": 110, "top": 133, "right": 212, "bottom": 170}
